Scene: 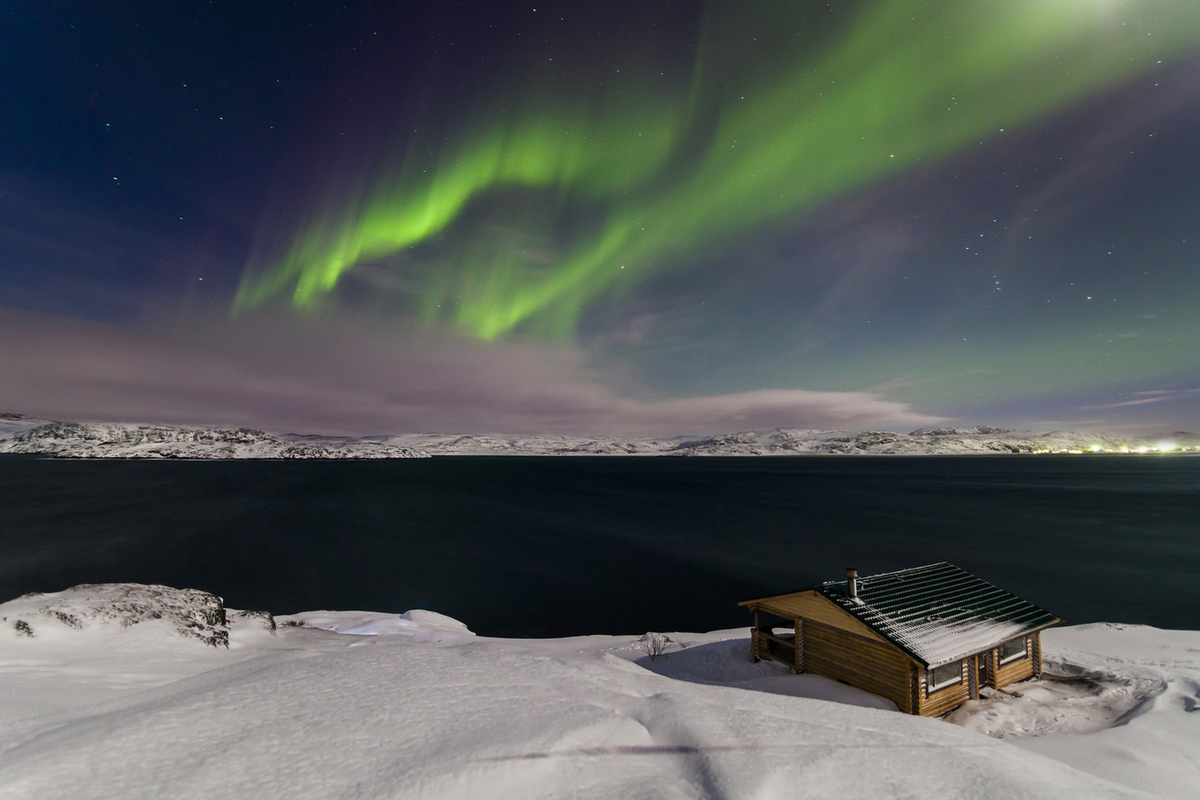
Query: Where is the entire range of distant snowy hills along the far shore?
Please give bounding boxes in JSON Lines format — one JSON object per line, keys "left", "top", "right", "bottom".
{"left": 0, "top": 414, "right": 1200, "bottom": 458}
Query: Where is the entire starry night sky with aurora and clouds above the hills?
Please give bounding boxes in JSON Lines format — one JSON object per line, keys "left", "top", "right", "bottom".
{"left": 0, "top": 0, "right": 1200, "bottom": 435}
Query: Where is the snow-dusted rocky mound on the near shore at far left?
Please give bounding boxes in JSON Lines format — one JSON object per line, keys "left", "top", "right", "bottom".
{"left": 0, "top": 583, "right": 236, "bottom": 648}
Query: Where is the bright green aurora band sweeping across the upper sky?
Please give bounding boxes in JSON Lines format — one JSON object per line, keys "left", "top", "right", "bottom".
{"left": 234, "top": 0, "right": 1200, "bottom": 339}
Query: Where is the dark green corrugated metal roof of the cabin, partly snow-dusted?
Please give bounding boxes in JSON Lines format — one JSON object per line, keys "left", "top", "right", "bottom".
{"left": 816, "top": 561, "right": 1060, "bottom": 667}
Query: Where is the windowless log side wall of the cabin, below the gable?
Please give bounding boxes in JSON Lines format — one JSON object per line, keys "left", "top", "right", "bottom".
{"left": 802, "top": 619, "right": 912, "bottom": 714}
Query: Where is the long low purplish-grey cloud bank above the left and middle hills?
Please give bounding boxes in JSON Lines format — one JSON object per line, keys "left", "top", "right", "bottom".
{"left": 0, "top": 309, "right": 943, "bottom": 435}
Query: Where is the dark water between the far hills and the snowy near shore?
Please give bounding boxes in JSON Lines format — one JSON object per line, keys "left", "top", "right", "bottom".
{"left": 0, "top": 456, "right": 1200, "bottom": 636}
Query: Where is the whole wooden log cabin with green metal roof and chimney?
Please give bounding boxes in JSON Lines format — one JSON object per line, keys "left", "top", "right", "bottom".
{"left": 738, "top": 563, "right": 1060, "bottom": 716}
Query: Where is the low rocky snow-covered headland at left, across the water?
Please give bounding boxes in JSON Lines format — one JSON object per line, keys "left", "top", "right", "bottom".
{"left": 0, "top": 422, "right": 425, "bottom": 458}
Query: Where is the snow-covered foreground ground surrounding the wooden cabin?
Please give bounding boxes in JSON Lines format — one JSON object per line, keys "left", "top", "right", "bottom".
{"left": 0, "top": 587, "right": 1200, "bottom": 800}
